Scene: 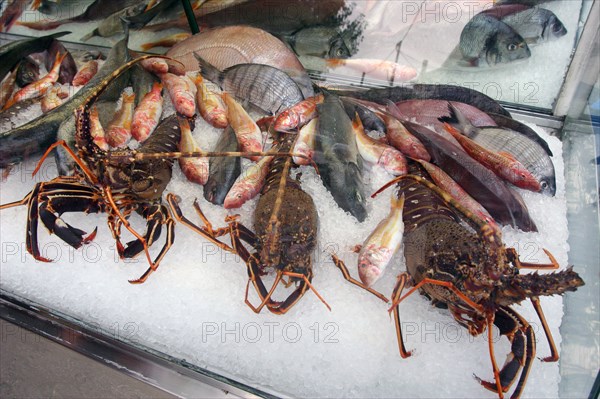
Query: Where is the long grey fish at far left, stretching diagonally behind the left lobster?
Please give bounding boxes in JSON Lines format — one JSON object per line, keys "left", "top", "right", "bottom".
{"left": 0, "top": 32, "right": 129, "bottom": 167}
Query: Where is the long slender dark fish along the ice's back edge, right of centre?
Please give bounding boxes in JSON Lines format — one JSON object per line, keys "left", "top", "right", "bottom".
{"left": 335, "top": 83, "right": 510, "bottom": 117}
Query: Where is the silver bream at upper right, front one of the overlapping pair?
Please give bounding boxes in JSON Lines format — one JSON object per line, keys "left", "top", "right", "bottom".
{"left": 459, "top": 13, "right": 531, "bottom": 66}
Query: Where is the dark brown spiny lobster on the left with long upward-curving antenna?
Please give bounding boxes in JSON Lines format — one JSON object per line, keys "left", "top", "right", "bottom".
{"left": 0, "top": 56, "right": 181, "bottom": 283}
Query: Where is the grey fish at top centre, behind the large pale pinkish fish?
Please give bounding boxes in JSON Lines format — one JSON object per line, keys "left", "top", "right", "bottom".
{"left": 283, "top": 26, "right": 352, "bottom": 58}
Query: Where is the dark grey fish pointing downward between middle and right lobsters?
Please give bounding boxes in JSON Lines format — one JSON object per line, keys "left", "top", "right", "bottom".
{"left": 314, "top": 93, "right": 367, "bottom": 222}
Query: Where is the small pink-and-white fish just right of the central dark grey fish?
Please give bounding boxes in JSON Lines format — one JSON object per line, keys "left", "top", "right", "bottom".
{"left": 352, "top": 114, "right": 407, "bottom": 176}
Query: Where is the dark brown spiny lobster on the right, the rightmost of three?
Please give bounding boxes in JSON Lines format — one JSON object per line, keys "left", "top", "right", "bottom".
{"left": 392, "top": 163, "right": 584, "bottom": 398}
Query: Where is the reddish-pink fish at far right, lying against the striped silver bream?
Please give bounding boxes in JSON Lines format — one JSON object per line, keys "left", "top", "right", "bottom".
{"left": 444, "top": 123, "right": 542, "bottom": 192}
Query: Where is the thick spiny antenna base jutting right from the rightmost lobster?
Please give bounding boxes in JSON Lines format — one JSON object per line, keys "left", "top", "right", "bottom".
{"left": 510, "top": 267, "right": 585, "bottom": 297}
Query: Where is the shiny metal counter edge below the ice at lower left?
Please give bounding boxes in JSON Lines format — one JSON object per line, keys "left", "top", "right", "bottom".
{"left": 0, "top": 290, "right": 283, "bottom": 398}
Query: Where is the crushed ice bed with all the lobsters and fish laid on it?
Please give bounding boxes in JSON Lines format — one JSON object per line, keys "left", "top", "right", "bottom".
{"left": 0, "top": 7, "right": 584, "bottom": 397}
